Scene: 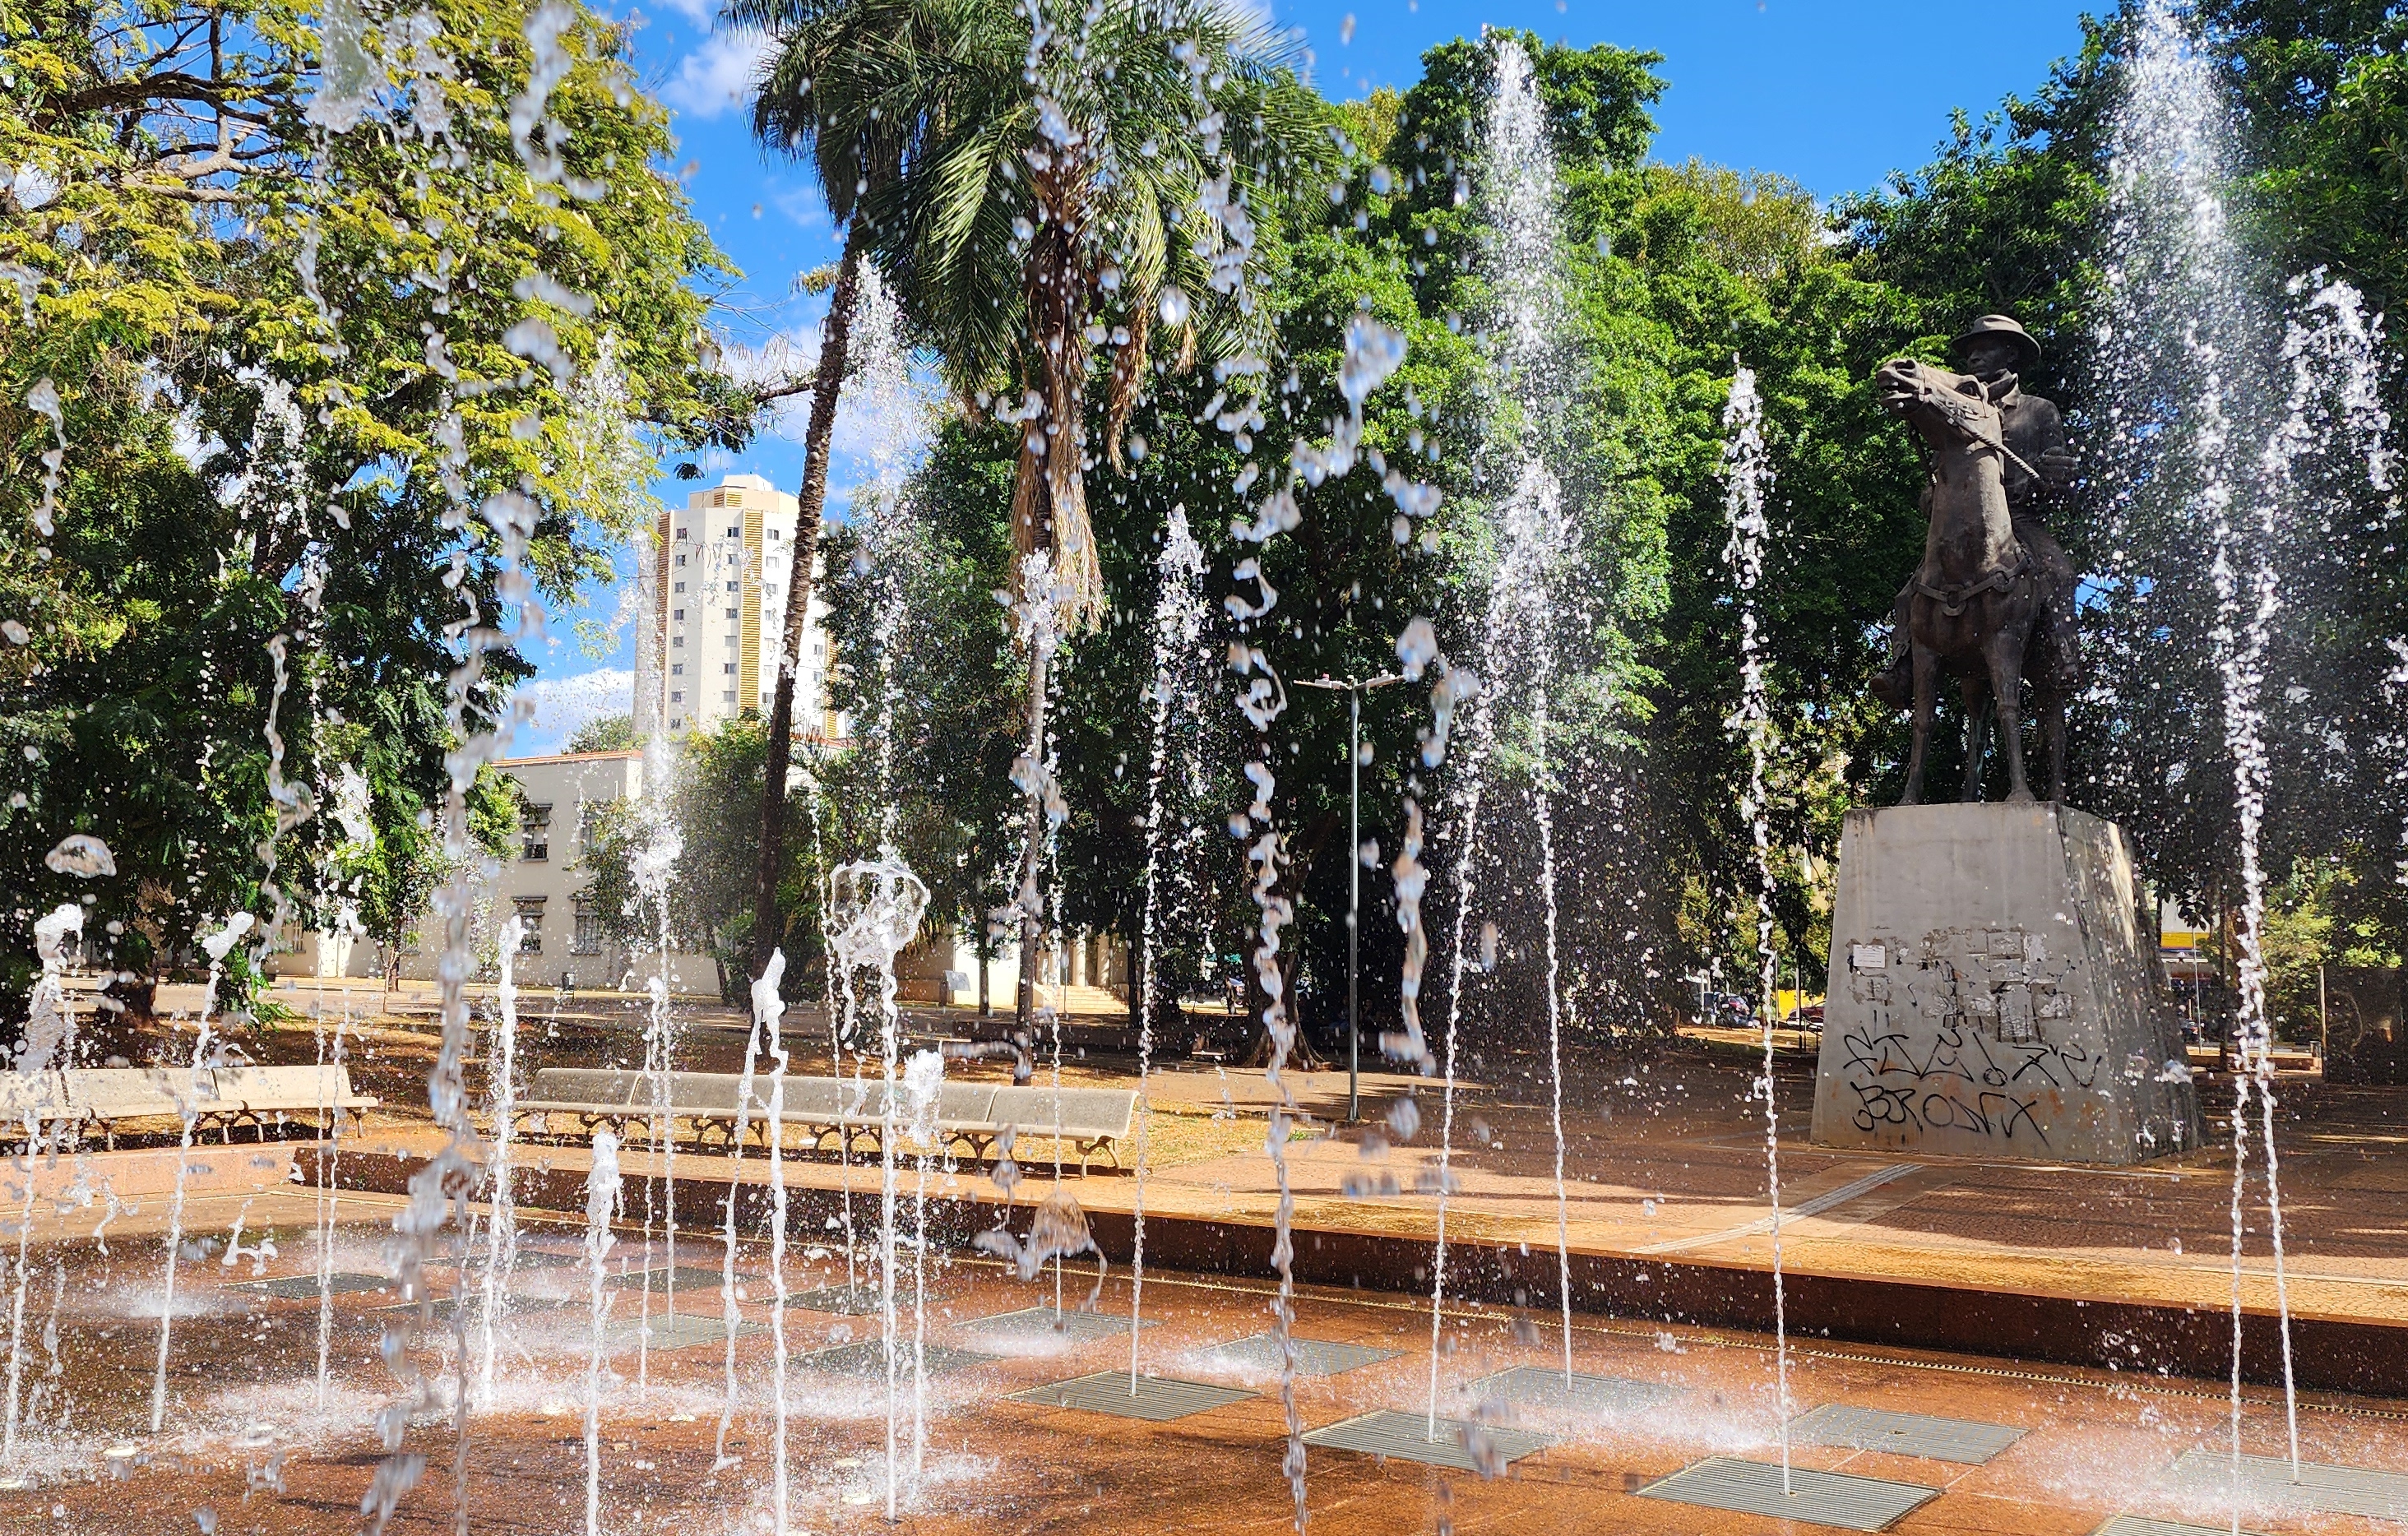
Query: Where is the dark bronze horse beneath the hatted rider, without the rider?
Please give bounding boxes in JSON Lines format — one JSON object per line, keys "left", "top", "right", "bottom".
{"left": 1873, "top": 359, "right": 2076, "bottom": 804}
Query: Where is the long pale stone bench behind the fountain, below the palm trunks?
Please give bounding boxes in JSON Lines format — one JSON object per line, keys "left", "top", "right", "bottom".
{"left": 513, "top": 1066, "right": 1137, "bottom": 1173}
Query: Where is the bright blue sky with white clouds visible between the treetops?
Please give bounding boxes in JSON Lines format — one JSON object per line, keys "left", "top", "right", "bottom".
{"left": 516, "top": 0, "right": 2105, "bottom": 753}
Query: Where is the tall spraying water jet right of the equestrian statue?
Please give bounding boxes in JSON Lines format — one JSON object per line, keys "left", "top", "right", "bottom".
{"left": 2092, "top": 0, "right": 2392, "bottom": 1490}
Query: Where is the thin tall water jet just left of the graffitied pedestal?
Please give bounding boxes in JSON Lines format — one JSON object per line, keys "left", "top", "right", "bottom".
{"left": 1722, "top": 359, "right": 1790, "bottom": 1492}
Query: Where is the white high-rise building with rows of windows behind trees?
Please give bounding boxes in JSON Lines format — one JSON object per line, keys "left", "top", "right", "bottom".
{"left": 636, "top": 474, "right": 845, "bottom": 739}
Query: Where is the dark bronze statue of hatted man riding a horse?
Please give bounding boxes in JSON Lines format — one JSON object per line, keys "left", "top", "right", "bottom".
{"left": 1873, "top": 316, "right": 2081, "bottom": 804}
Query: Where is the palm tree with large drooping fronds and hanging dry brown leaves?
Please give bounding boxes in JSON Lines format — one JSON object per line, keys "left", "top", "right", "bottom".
{"left": 857, "top": 0, "right": 1334, "bottom": 1028}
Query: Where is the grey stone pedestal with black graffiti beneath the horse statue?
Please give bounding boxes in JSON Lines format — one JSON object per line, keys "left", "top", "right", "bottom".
{"left": 1813, "top": 804, "right": 2198, "bottom": 1163}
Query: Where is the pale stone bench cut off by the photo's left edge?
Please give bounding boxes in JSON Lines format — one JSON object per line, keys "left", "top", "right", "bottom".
{"left": 0, "top": 1066, "right": 378, "bottom": 1149}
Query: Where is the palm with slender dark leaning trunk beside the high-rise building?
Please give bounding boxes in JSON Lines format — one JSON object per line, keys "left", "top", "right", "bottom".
{"left": 722, "top": 0, "right": 975, "bottom": 978}
